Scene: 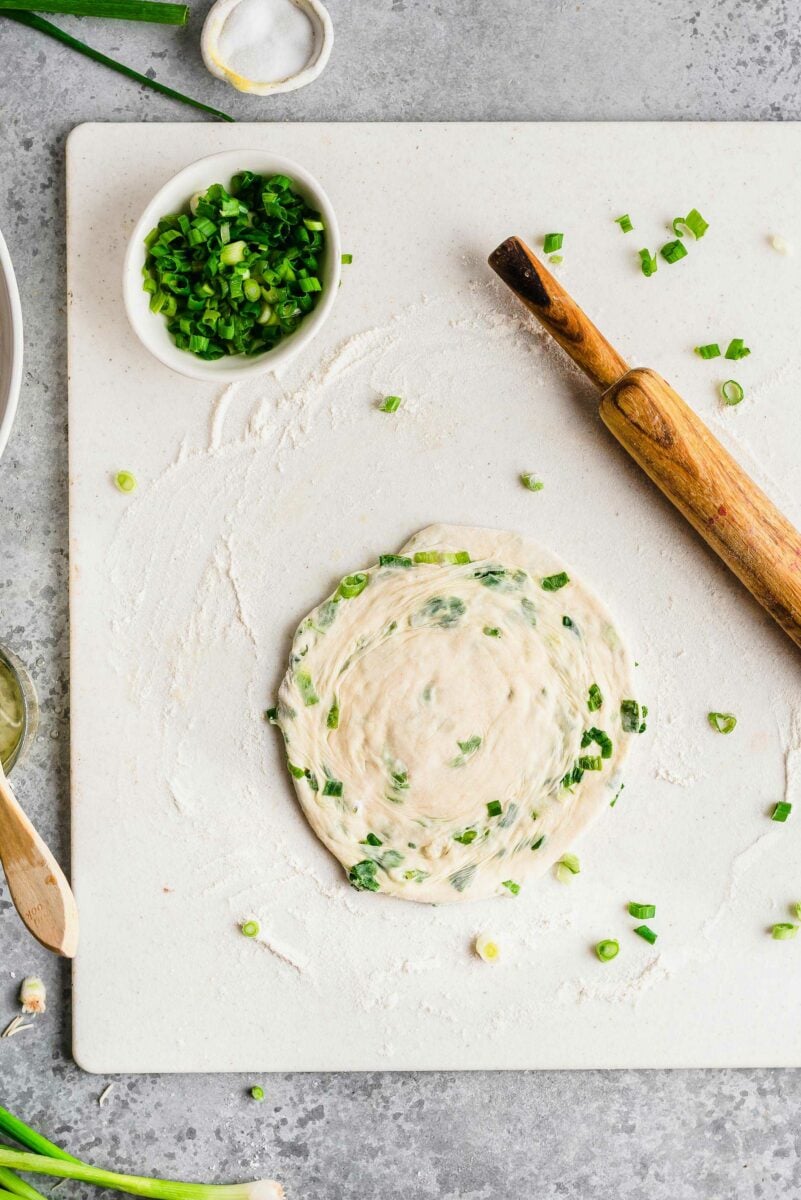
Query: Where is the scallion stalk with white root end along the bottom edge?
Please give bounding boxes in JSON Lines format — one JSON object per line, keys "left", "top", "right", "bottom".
{"left": 0, "top": 1146, "right": 284, "bottom": 1200}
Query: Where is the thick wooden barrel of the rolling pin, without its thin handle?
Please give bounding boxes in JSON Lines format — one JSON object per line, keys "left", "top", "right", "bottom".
{"left": 601, "top": 370, "right": 801, "bottom": 646}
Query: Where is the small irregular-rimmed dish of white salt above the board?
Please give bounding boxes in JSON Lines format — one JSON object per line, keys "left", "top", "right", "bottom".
{"left": 200, "top": 0, "right": 333, "bottom": 96}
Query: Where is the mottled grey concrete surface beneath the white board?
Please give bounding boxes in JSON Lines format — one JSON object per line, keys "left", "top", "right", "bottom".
{"left": 0, "top": 0, "right": 801, "bottom": 1200}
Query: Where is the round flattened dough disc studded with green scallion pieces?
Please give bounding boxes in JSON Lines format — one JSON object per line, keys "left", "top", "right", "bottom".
{"left": 276, "top": 526, "right": 636, "bottom": 904}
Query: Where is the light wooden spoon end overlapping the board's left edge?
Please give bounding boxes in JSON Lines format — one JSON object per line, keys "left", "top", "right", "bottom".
{"left": 0, "top": 763, "right": 78, "bottom": 959}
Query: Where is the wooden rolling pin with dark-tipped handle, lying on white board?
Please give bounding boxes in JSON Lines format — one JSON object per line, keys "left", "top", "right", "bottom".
{"left": 489, "top": 238, "right": 801, "bottom": 646}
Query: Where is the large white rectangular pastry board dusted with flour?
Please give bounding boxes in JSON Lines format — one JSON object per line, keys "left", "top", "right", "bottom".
{"left": 68, "top": 124, "right": 801, "bottom": 1072}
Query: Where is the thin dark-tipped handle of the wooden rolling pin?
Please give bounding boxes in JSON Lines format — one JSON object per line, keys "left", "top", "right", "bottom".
{"left": 489, "top": 238, "right": 628, "bottom": 391}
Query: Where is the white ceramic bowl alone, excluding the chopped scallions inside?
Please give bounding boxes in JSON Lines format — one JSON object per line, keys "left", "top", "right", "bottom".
{"left": 122, "top": 149, "right": 342, "bottom": 383}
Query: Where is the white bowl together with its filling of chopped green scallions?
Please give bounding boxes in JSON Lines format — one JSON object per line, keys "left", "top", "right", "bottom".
{"left": 124, "top": 150, "right": 341, "bottom": 383}
